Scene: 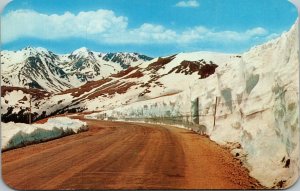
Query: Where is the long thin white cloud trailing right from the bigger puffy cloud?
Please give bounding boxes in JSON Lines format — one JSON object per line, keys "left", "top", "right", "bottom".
{"left": 102, "top": 23, "right": 269, "bottom": 44}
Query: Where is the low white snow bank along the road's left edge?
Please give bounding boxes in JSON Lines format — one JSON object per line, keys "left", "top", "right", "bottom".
{"left": 1, "top": 117, "right": 88, "bottom": 150}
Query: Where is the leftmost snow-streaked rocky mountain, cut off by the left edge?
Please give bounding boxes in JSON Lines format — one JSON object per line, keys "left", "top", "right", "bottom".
{"left": 1, "top": 47, "right": 74, "bottom": 91}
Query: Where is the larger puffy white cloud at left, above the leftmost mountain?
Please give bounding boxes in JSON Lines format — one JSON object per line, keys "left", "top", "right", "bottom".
{"left": 1, "top": 9, "right": 127, "bottom": 43}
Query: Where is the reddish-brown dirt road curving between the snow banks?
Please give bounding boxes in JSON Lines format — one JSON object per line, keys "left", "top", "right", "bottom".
{"left": 2, "top": 120, "right": 259, "bottom": 190}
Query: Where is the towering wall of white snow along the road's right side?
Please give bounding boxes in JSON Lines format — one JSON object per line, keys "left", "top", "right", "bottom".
{"left": 87, "top": 22, "right": 299, "bottom": 188}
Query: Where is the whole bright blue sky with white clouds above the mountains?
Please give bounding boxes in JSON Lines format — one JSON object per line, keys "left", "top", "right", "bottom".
{"left": 1, "top": 0, "right": 298, "bottom": 56}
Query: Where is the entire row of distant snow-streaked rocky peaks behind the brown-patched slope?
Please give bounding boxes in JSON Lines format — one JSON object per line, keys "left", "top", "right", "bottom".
{"left": 1, "top": 47, "right": 151, "bottom": 92}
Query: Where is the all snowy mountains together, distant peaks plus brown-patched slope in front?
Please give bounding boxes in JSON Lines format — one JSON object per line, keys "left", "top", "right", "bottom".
{"left": 1, "top": 47, "right": 241, "bottom": 122}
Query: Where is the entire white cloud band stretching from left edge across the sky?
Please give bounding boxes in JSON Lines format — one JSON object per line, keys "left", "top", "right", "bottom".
{"left": 1, "top": 9, "right": 274, "bottom": 45}
